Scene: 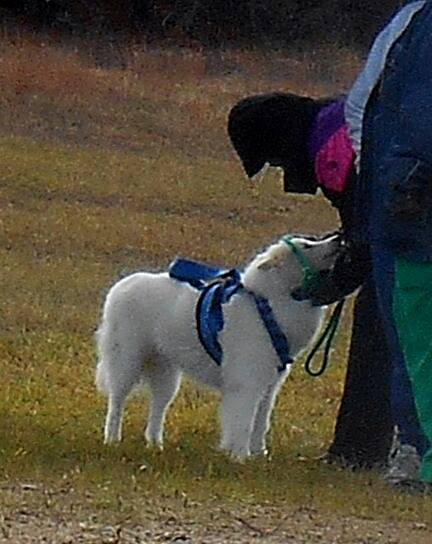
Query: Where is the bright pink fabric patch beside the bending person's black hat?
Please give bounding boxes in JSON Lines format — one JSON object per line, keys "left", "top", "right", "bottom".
{"left": 315, "top": 125, "right": 355, "bottom": 193}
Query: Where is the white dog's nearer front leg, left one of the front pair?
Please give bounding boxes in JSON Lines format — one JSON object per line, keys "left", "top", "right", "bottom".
{"left": 220, "top": 388, "right": 259, "bottom": 461}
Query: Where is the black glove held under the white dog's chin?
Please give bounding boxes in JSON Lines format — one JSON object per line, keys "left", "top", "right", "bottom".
{"left": 291, "top": 243, "right": 370, "bottom": 306}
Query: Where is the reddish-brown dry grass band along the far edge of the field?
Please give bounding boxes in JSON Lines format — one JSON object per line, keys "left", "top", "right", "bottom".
{"left": 0, "top": 37, "right": 359, "bottom": 156}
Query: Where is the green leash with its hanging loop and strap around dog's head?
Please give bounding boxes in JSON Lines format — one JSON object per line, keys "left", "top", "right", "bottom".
{"left": 282, "top": 236, "right": 345, "bottom": 378}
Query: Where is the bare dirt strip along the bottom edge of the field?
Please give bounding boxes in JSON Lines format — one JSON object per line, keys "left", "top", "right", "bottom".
{"left": 0, "top": 484, "right": 432, "bottom": 544}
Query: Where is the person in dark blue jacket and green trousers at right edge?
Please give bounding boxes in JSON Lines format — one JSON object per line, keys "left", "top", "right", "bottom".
{"left": 230, "top": 0, "right": 432, "bottom": 491}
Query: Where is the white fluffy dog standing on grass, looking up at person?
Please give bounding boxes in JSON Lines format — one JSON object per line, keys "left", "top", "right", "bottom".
{"left": 96, "top": 236, "right": 340, "bottom": 460}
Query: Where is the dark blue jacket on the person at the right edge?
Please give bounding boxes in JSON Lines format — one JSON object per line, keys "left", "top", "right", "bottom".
{"left": 355, "top": 1, "right": 432, "bottom": 261}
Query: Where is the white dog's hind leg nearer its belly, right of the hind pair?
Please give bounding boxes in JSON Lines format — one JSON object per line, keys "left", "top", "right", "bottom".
{"left": 145, "top": 361, "right": 181, "bottom": 448}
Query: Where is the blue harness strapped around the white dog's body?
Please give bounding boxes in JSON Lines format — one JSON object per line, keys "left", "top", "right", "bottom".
{"left": 169, "top": 259, "right": 293, "bottom": 372}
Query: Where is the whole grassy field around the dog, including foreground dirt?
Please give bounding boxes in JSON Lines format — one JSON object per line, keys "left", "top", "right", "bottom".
{"left": 0, "top": 38, "right": 432, "bottom": 544}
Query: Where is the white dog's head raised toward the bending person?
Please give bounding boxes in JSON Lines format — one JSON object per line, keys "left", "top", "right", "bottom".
{"left": 251, "top": 233, "right": 343, "bottom": 289}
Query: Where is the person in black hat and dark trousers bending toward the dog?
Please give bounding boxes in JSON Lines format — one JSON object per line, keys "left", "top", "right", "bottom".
{"left": 228, "top": 93, "right": 393, "bottom": 467}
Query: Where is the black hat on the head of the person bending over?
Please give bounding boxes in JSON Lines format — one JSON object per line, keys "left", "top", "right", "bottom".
{"left": 228, "top": 93, "right": 325, "bottom": 194}
